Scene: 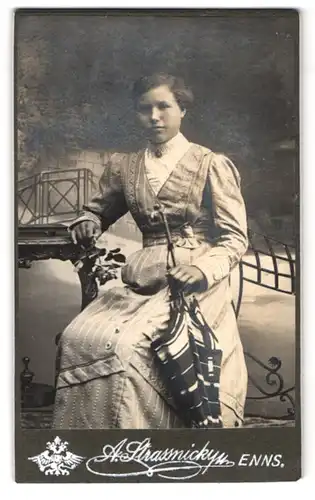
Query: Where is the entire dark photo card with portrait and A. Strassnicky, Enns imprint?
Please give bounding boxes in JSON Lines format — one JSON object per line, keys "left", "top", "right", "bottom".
{"left": 15, "top": 9, "right": 301, "bottom": 483}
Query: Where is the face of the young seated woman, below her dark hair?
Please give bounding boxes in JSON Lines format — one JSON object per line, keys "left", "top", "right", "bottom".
{"left": 137, "top": 85, "right": 185, "bottom": 144}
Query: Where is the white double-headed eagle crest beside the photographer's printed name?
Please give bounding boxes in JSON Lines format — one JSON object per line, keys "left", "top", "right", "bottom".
{"left": 28, "top": 436, "right": 85, "bottom": 476}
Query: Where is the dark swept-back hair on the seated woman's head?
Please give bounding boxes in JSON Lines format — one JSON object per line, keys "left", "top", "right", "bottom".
{"left": 133, "top": 73, "right": 194, "bottom": 109}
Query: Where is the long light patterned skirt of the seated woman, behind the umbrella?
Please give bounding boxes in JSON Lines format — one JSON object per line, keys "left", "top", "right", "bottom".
{"left": 53, "top": 272, "right": 247, "bottom": 429}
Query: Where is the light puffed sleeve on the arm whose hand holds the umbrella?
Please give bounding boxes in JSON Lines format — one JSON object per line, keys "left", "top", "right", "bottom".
{"left": 193, "top": 154, "right": 248, "bottom": 286}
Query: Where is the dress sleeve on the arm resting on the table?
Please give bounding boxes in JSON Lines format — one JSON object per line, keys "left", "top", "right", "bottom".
{"left": 71, "top": 154, "right": 129, "bottom": 232}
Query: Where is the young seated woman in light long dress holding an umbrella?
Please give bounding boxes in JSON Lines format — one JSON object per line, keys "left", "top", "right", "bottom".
{"left": 53, "top": 74, "right": 247, "bottom": 429}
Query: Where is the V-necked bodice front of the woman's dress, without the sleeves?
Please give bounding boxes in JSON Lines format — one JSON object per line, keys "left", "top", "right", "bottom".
{"left": 122, "top": 144, "right": 215, "bottom": 243}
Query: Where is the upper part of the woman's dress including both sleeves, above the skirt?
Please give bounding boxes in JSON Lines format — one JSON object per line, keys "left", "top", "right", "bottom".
{"left": 78, "top": 144, "right": 247, "bottom": 296}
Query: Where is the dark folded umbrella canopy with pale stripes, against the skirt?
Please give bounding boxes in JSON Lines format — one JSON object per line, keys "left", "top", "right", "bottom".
{"left": 152, "top": 294, "right": 222, "bottom": 428}
